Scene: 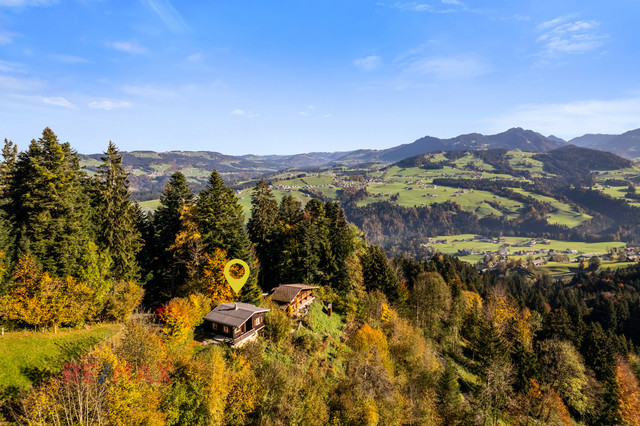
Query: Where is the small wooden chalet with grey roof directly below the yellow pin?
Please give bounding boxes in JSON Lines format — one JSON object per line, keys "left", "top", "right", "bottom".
{"left": 204, "top": 302, "right": 269, "bottom": 346}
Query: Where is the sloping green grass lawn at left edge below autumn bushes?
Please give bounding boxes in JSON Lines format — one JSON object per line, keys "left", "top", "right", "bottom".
{"left": 0, "top": 324, "right": 120, "bottom": 388}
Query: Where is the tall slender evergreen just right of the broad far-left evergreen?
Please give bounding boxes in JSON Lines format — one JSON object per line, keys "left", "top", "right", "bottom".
{"left": 94, "top": 142, "right": 142, "bottom": 280}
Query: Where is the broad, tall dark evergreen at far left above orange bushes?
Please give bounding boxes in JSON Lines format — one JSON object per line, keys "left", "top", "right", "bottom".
{"left": 6, "top": 128, "right": 92, "bottom": 276}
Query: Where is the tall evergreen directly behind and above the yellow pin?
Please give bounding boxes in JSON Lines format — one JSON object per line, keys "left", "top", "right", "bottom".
{"left": 196, "top": 170, "right": 262, "bottom": 303}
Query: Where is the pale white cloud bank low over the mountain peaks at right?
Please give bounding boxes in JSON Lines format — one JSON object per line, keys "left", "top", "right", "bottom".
{"left": 484, "top": 97, "right": 640, "bottom": 139}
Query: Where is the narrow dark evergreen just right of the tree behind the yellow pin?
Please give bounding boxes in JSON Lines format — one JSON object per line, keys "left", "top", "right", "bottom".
{"left": 247, "top": 179, "right": 279, "bottom": 289}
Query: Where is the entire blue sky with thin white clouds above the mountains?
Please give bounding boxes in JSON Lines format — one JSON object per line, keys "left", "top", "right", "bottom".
{"left": 0, "top": 0, "right": 640, "bottom": 154}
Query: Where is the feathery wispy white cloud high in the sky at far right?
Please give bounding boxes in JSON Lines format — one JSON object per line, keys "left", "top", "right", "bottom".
{"left": 538, "top": 15, "right": 608, "bottom": 57}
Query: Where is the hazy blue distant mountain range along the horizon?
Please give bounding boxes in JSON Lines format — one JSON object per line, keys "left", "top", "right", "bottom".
{"left": 81, "top": 127, "right": 640, "bottom": 195}
